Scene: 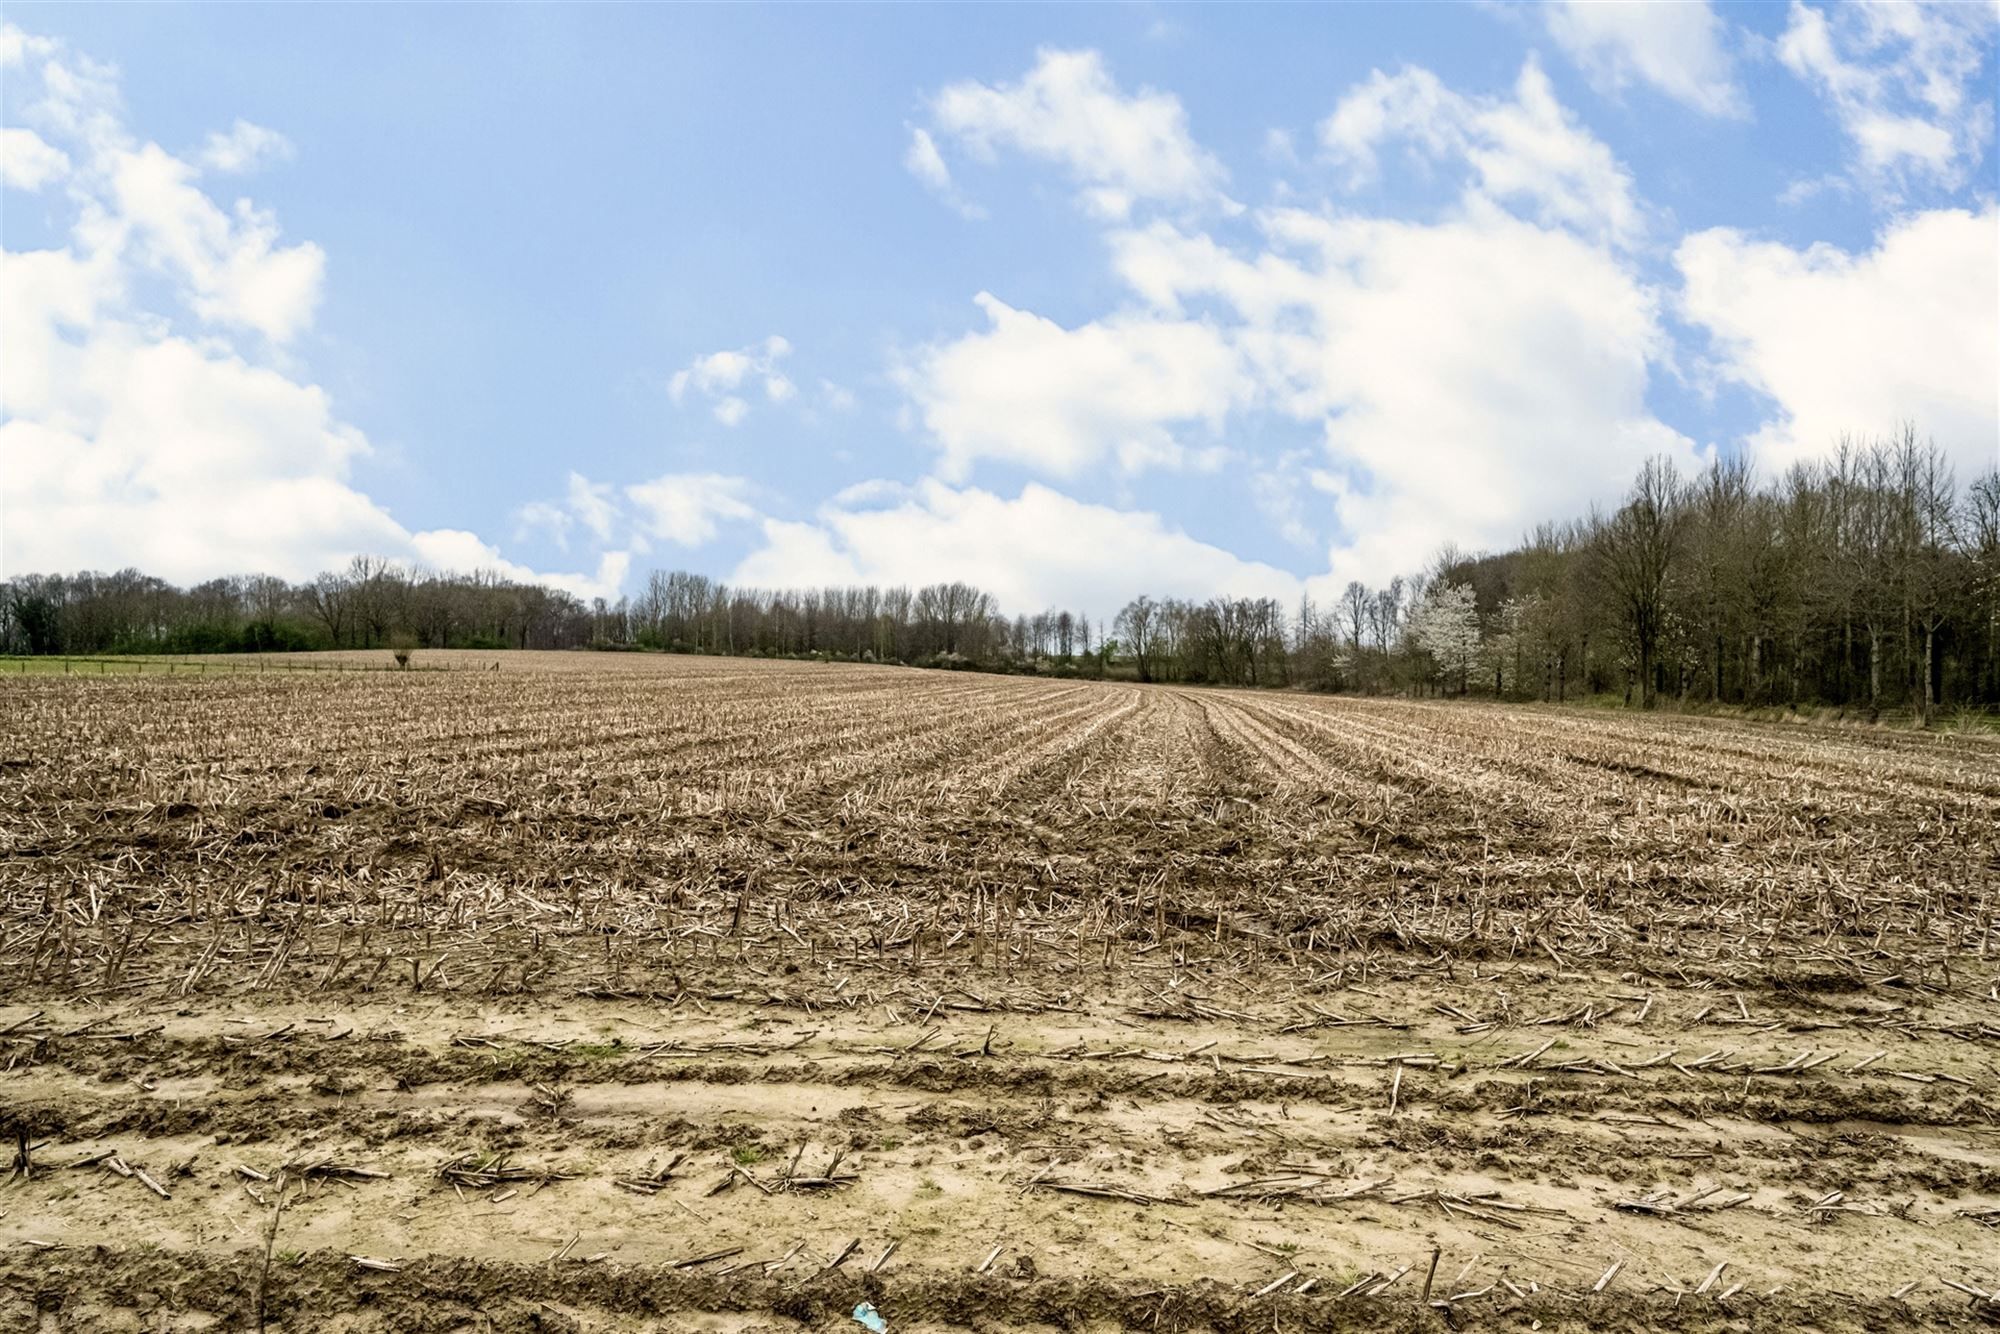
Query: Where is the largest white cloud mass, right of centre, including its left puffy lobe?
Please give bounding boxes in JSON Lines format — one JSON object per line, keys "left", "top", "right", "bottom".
{"left": 900, "top": 60, "right": 1704, "bottom": 586}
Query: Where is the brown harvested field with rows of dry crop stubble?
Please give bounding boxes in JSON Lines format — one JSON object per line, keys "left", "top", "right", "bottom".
{"left": 0, "top": 654, "right": 2000, "bottom": 1334}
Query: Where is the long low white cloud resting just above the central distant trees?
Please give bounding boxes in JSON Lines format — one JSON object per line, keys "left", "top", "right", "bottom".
{"left": 732, "top": 482, "right": 1300, "bottom": 616}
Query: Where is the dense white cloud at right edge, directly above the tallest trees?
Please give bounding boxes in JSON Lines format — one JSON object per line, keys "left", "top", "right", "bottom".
{"left": 1674, "top": 206, "right": 2000, "bottom": 480}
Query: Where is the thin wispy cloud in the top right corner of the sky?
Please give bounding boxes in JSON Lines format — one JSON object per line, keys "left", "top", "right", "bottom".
{"left": 1778, "top": 0, "right": 2000, "bottom": 204}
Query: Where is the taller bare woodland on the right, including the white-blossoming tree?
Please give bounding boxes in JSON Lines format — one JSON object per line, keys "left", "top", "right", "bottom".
{"left": 1264, "top": 426, "right": 2000, "bottom": 722}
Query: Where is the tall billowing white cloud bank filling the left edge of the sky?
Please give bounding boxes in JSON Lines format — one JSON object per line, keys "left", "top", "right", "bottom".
{"left": 0, "top": 28, "right": 622, "bottom": 590}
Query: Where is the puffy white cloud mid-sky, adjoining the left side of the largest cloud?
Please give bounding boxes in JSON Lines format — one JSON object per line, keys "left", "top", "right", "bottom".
{"left": 898, "top": 292, "right": 1252, "bottom": 480}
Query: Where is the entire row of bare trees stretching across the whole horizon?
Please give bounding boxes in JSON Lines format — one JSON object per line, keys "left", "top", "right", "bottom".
{"left": 0, "top": 428, "right": 2000, "bottom": 720}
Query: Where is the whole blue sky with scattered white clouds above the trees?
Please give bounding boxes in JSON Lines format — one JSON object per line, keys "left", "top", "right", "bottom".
{"left": 0, "top": 0, "right": 2000, "bottom": 616}
